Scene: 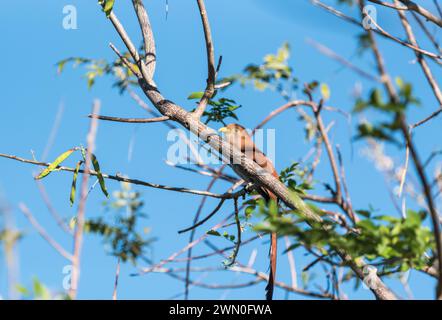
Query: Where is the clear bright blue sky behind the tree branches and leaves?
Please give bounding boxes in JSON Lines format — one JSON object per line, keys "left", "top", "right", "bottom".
{"left": 0, "top": 0, "right": 442, "bottom": 299}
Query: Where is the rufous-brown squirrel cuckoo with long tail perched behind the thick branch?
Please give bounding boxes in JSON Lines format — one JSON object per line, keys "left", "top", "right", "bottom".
{"left": 219, "top": 123, "right": 279, "bottom": 300}
